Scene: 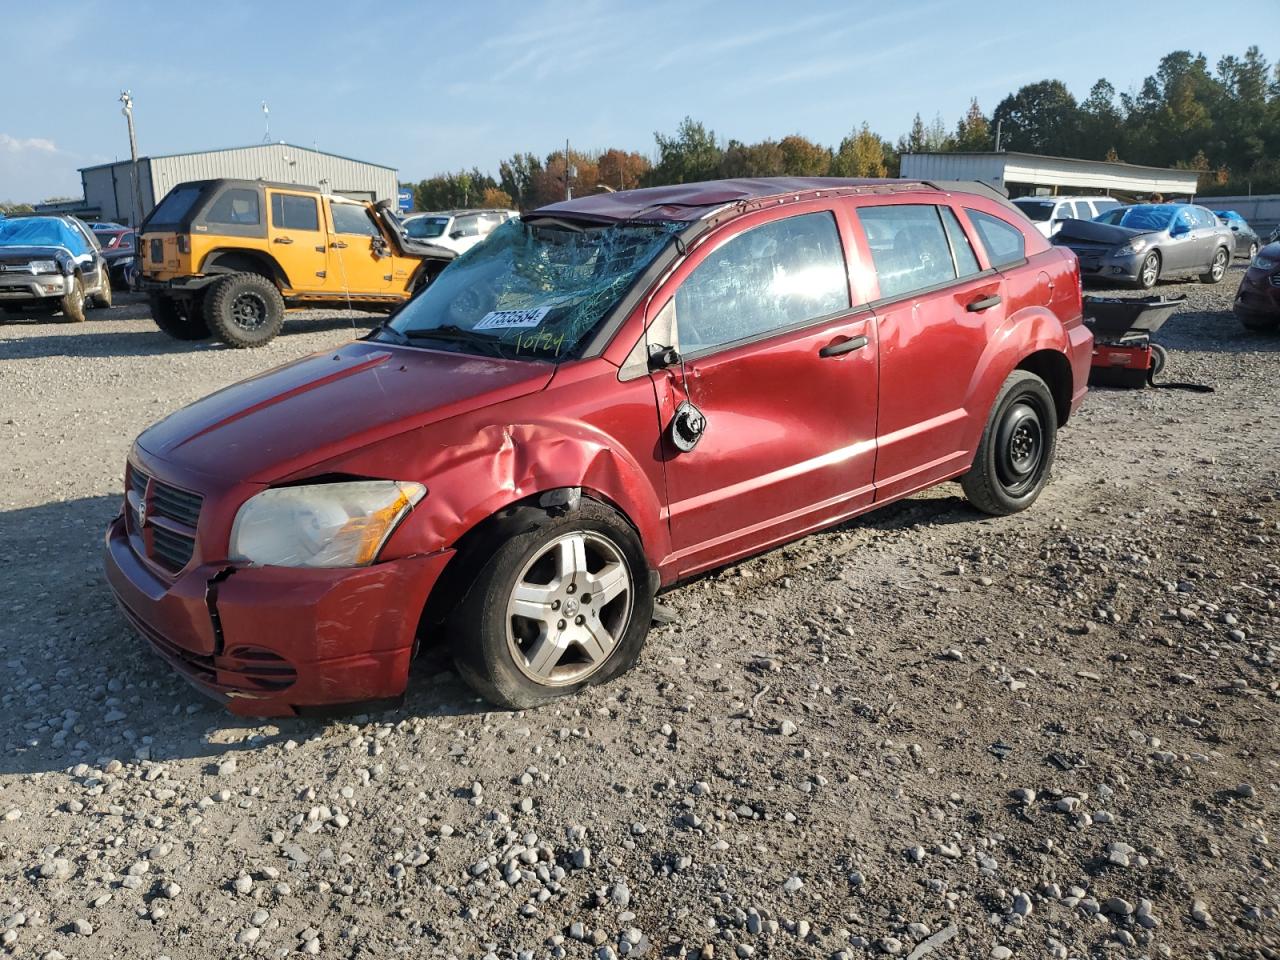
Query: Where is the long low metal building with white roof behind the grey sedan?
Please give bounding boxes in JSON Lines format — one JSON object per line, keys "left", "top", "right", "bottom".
{"left": 902, "top": 151, "right": 1199, "bottom": 200}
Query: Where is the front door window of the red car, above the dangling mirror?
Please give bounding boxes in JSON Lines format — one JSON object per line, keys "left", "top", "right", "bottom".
{"left": 676, "top": 212, "right": 850, "bottom": 355}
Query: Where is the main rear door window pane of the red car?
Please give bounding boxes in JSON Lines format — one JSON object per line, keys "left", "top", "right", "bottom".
{"left": 858, "top": 204, "right": 977, "bottom": 300}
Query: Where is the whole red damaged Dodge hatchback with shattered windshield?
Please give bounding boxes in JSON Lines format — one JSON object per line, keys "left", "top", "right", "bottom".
{"left": 106, "top": 179, "right": 1092, "bottom": 716}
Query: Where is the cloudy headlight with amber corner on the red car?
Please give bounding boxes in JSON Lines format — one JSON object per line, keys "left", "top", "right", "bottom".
{"left": 229, "top": 480, "right": 426, "bottom": 567}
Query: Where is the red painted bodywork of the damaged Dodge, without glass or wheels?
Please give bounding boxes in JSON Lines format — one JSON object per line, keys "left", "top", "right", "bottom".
{"left": 105, "top": 179, "right": 1092, "bottom": 716}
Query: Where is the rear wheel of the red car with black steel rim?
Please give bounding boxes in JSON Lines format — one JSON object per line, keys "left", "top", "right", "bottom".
{"left": 960, "top": 370, "right": 1057, "bottom": 517}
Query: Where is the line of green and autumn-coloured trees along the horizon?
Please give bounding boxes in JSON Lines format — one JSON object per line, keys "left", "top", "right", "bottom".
{"left": 406, "top": 46, "right": 1280, "bottom": 210}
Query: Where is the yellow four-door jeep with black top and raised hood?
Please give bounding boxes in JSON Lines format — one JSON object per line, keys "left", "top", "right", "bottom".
{"left": 137, "top": 179, "right": 457, "bottom": 347}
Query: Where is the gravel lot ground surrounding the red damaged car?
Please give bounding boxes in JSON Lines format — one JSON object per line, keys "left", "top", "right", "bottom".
{"left": 0, "top": 268, "right": 1280, "bottom": 960}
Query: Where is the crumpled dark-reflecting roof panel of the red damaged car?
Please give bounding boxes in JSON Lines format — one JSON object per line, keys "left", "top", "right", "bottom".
{"left": 530, "top": 177, "right": 929, "bottom": 221}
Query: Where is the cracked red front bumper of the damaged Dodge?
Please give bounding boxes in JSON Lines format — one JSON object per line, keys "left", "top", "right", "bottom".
{"left": 104, "top": 517, "right": 453, "bottom": 717}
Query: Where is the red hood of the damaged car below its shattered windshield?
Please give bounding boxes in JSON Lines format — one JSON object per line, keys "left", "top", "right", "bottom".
{"left": 137, "top": 340, "right": 554, "bottom": 483}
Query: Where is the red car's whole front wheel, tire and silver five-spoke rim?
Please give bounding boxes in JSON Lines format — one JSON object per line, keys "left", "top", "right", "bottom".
{"left": 449, "top": 499, "right": 653, "bottom": 709}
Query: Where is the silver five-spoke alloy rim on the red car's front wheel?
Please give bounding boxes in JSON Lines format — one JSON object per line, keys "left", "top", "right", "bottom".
{"left": 506, "top": 531, "right": 635, "bottom": 686}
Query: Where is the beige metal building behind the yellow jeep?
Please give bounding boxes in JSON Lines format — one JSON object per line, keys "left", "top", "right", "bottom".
{"left": 76, "top": 143, "right": 399, "bottom": 224}
